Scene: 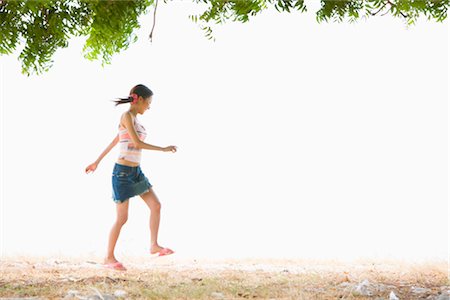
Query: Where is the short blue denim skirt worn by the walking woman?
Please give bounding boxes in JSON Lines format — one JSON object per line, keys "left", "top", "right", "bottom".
{"left": 112, "top": 163, "right": 152, "bottom": 203}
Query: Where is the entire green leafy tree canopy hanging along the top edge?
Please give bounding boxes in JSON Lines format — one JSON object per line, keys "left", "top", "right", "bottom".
{"left": 0, "top": 0, "right": 450, "bottom": 76}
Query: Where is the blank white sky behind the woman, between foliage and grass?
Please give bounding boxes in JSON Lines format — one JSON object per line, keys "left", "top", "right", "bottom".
{"left": 0, "top": 1, "right": 449, "bottom": 260}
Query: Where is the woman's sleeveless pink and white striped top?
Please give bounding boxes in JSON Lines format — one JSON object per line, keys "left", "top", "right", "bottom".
{"left": 119, "top": 113, "right": 147, "bottom": 163}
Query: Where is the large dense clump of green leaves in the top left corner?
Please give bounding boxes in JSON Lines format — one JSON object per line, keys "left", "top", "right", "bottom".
{"left": 0, "top": 0, "right": 153, "bottom": 75}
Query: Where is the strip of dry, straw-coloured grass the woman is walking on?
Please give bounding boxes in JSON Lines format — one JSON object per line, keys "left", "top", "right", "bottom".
{"left": 0, "top": 255, "right": 450, "bottom": 300}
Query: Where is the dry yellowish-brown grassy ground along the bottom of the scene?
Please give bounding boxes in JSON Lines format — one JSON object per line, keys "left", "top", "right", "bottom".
{"left": 0, "top": 261, "right": 449, "bottom": 299}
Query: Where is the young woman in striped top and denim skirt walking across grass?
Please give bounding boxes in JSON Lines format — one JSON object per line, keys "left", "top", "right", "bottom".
{"left": 85, "top": 84, "right": 177, "bottom": 271}
